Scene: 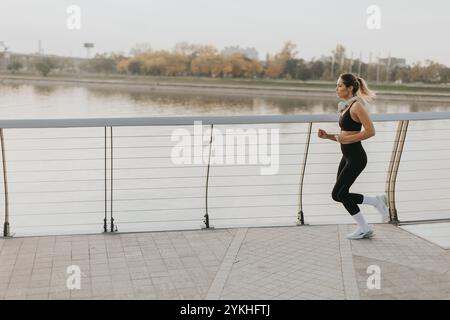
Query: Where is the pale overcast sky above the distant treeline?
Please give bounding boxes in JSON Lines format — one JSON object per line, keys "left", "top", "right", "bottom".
{"left": 0, "top": 0, "right": 450, "bottom": 66}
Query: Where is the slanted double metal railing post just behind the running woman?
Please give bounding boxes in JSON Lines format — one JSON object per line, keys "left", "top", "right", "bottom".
{"left": 386, "top": 120, "right": 409, "bottom": 224}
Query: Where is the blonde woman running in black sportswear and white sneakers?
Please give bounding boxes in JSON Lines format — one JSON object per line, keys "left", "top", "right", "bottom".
{"left": 318, "top": 73, "right": 389, "bottom": 240}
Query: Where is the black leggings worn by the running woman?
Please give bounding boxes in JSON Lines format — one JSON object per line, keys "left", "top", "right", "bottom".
{"left": 331, "top": 142, "right": 367, "bottom": 216}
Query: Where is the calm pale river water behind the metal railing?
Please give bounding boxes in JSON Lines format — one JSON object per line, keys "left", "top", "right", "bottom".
{"left": 0, "top": 85, "right": 450, "bottom": 236}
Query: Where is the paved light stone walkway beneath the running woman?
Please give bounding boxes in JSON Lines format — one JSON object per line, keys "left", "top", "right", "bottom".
{"left": 0, "top": 225, "right": 450, "bottom": 300}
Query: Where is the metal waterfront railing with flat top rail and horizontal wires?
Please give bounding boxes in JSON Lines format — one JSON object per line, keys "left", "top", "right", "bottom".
{"left": 0, "top": 112, "right": 450, "bottom": 236}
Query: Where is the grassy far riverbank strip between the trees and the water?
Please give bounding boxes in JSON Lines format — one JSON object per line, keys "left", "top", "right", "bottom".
{"left": 0, "top": 74, "right": 450, "bottom": 103}
